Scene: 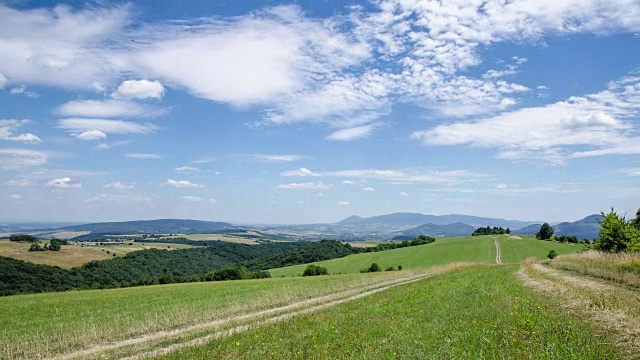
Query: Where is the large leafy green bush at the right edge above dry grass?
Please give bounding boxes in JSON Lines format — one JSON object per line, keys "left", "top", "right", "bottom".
{"left": 593, "top": 208, "right": 640, "bottom": 252}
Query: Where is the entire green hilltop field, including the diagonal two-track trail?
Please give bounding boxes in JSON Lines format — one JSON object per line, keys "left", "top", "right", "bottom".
{"left": 0, "top": 236, "right": 640, "bottom": 359}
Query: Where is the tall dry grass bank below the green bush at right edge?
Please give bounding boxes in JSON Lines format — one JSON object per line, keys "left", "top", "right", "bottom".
{"left": 548, "top": 251, "right": 640, "bottom": 287}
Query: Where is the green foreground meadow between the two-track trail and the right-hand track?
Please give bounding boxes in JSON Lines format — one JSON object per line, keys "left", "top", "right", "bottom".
{"left": 161, "top": 265, "right": 624, "bottom": 359}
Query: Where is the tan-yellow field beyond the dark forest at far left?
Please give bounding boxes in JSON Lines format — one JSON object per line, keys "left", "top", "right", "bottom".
{"left": 0, "top": 240, "right": 192, "bottom": 269}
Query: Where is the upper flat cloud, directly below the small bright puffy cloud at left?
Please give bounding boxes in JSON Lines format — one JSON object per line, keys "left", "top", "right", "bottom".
{"left": 56, "top": 99, "right": 164, "bottom": 118}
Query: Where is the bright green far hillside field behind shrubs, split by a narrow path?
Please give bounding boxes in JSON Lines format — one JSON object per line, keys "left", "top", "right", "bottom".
{"left": 269, "top": 236, "right": 580, "bottom": 277}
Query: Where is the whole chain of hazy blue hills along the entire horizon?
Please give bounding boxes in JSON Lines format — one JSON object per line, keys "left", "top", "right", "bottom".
{"left": 0, "top": 213, "right": 602, "bottom": 241}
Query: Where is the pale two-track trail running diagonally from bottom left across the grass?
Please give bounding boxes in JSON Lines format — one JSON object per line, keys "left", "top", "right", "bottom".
{"left": 54, "top": 263, "right": 477, "bottom": 359}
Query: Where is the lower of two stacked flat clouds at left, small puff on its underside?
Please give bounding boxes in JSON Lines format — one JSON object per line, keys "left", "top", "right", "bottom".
{"left": 58, "top": 118, "right": 157, "bottom": 140}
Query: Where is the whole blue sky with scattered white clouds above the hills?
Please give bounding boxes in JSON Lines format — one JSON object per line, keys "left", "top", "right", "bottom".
{"left": 0, "top": 0, "right": 640, "bottom": 223}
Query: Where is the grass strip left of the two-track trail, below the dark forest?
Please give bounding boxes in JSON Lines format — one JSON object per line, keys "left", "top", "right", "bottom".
{"left": 0, "top": 271, "right": 436, "bottom": 359}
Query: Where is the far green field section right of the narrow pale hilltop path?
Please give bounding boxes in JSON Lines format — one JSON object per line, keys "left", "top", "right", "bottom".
{"left": 496, "top": 235, "right": 582, "bottom": 263}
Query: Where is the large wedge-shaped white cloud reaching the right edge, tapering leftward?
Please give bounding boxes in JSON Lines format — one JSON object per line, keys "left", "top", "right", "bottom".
{"left": 411, "top": 77, "right": 640, "bottom": 164}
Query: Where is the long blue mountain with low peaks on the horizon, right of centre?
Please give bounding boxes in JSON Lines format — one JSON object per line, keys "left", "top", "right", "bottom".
{"left": 336, "top": 213, "right": 541, "bottom": 229}
